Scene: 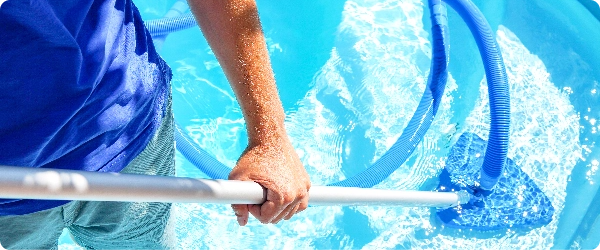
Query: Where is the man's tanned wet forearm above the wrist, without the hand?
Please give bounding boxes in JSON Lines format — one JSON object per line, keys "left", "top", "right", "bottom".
{"left": 188, "top": 0, "right": 285, "bottom": 145}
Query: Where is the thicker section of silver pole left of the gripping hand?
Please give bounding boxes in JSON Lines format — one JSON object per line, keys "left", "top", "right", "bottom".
{"left": 0, "top": 166, "right": 265, "bottom": 204}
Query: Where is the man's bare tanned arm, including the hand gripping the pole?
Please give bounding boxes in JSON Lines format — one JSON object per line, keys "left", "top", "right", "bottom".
{"left": 188, "top": 0, "right": 310, "bottom": 226}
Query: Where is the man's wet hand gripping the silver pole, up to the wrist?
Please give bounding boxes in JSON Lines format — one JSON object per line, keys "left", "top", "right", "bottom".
{"left": 229, "top": 135, "right": 310, "bottom": 226}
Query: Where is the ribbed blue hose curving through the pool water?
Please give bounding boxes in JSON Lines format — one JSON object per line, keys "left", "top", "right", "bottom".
{"left": 146, "top": 0, "right": 510, "bottom": 190}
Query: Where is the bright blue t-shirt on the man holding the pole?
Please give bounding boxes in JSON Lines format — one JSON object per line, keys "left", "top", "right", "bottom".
{"left": 0, "top": 0, "right": 171, "bottom": 215}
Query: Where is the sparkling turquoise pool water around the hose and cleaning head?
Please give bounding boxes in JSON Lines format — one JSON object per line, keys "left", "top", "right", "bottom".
{"left": 60, "top": 0, "right": 600, "bottom": 249}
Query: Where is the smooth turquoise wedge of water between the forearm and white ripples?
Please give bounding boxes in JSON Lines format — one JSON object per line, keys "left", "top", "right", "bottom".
{"left": 257, "top": 0, "right": 345, "bottom": 111}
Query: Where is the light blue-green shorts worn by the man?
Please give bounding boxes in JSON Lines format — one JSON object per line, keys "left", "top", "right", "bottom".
{"left": 0, "top": 103, "right": 175, "bottom": 250}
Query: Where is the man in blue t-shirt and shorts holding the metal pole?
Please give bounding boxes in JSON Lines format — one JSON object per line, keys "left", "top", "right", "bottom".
{"left": 0, "top": 0, "right": 310, "bottom": 249}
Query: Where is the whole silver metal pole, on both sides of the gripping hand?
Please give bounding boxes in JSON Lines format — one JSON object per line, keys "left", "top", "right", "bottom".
{"left": 0, "top": 166, "right": 469, "bottom": 207}
